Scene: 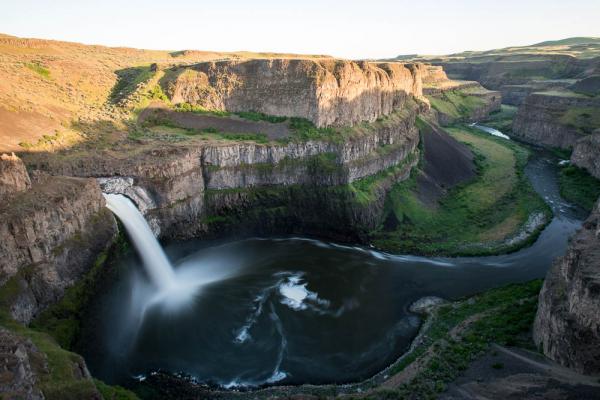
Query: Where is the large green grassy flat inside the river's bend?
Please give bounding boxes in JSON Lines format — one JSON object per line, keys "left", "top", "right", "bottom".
{"left": 372, "top": 127, "right": 550, "bottom": 255}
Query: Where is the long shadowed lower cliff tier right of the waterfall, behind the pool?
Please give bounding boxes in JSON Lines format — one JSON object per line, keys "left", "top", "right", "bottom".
{"left": 32, "top": 102, "right": 419, "bottom": 239}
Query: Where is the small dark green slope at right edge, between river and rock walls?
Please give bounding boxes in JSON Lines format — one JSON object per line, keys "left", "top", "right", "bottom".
{"left": 558, "top": 165, "right": 600, "bottom": 211}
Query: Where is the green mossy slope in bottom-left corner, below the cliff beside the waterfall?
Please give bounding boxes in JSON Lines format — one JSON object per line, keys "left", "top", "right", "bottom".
{"left": 0, "top": 231, "right": 137, "bottom": 400}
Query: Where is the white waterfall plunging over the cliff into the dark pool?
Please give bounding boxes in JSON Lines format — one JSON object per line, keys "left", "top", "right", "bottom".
{"left": 104, "top": 193, "right": 175, "bottom": 289}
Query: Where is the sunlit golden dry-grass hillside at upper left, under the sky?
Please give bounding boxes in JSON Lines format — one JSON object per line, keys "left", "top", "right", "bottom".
{"left": 0, "top": 34, "right": 332, "bottom": 152}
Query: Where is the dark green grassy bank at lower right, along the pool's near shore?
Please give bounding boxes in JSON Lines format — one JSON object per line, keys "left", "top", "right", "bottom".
{"left": 376, "top": 280, "right": 542, "bottom": 399}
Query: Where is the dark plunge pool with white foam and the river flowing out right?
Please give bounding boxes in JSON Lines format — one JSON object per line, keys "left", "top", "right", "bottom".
{"left": 82, "top": 158, "right": 580, "bottom": 388}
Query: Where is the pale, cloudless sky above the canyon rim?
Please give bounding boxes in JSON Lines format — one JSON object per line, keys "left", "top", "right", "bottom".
{"left": 0, "top": 0, "right": 600, "bottom": 59}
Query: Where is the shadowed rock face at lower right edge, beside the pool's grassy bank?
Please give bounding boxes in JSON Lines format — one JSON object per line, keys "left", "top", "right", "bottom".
{"left": 534, "top": 202, "right": 600, "bottom": 375}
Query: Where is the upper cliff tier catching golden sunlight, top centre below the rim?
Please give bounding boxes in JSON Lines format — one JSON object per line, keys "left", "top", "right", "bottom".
{"left": 162, "top": 59, "right": 428, "bottom": 127}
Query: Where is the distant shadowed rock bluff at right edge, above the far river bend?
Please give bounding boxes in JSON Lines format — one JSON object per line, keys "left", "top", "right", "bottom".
{"left": 512, "top": 92, "right": 600, "bottom": 148}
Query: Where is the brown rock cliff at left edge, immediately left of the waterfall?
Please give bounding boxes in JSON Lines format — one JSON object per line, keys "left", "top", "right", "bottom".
{"left": 0, "top": 155, "right": 116, "bottom": 323}
